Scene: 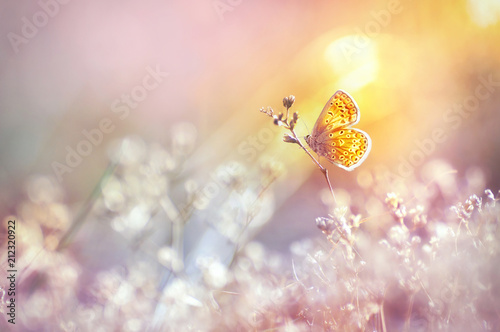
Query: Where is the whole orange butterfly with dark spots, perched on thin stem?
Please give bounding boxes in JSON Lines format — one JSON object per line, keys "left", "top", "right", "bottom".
{"left": 305, "top": 90, "right": 372, "bottom": 171}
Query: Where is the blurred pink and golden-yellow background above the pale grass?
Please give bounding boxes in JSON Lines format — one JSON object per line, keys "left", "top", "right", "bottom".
{"left": 0, "top": 0, "right": 500, "bottom": 330}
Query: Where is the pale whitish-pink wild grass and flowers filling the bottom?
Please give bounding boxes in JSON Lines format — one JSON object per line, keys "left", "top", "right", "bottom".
{"left": 0, "top": 110, "right": 500, "bottom": 331}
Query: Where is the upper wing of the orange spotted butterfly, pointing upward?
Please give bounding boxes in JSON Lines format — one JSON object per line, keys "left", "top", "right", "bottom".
{"left": 311, "top": 90, "right": 360, "bottom": 138}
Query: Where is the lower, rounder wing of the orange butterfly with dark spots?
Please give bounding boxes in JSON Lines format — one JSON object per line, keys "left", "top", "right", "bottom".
{"left": 317, "top": 128, "right": 372, "bottom": 171}
